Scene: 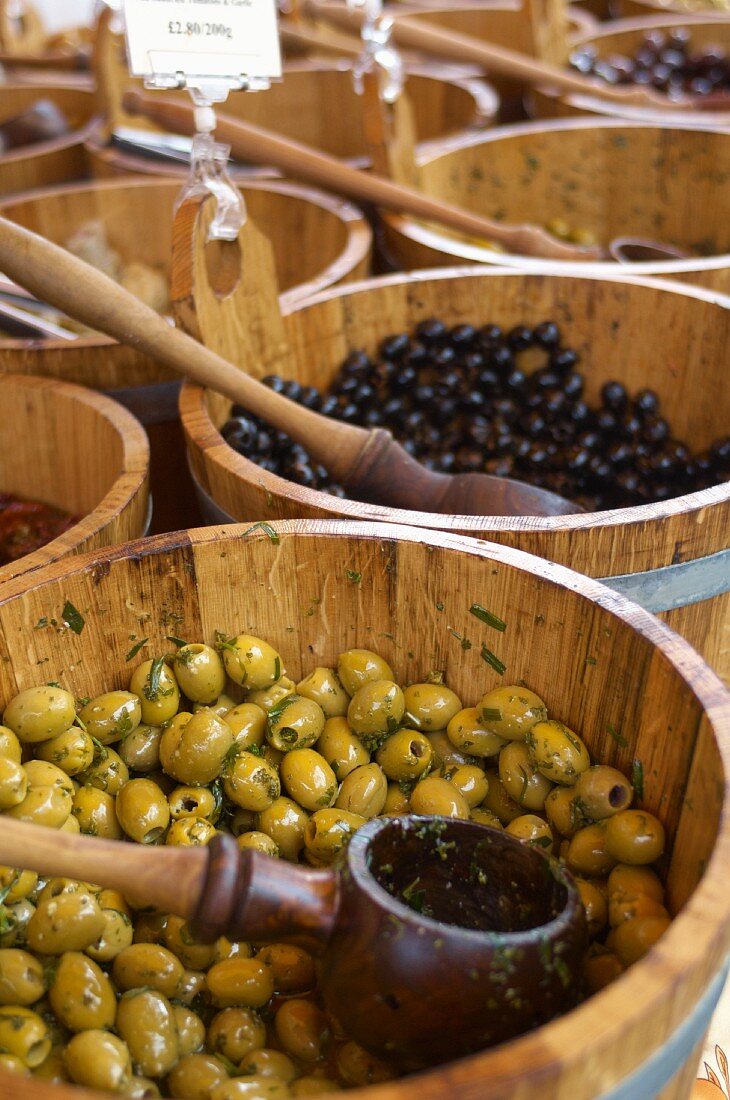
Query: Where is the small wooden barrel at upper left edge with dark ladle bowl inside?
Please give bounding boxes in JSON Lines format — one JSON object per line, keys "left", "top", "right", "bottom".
{"left": 0, "top": 84, "right": 95, "bottom": 195}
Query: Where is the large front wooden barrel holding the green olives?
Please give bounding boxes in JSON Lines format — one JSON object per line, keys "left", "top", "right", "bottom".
{"left": 0, "top": 521, "right": 730, "bottom": 1100}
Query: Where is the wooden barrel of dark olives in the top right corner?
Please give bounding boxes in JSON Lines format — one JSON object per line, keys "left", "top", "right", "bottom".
{"left": 529, "top": 14, "right": 730, "bottom": 124}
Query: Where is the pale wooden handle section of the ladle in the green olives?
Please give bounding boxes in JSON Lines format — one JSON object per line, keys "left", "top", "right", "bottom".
{"left": 0, "top": 814, "right": 208, "bottom": 919}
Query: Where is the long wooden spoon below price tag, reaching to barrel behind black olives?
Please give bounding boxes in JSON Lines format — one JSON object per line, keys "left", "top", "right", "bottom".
{"left": 122, "top": 90, "right": 602, "bottom": 262}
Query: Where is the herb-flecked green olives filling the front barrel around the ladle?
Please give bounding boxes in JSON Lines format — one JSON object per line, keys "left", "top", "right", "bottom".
{"left": 0, "top": 638, "right": 671, "bottom": 1100}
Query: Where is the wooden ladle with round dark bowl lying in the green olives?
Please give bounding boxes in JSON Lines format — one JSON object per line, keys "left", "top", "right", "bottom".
{"left": 0, "top": 816, "right": 586, "bottom": 1070}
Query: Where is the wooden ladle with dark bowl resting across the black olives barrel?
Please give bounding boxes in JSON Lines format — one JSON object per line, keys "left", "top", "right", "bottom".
{"left": 0, "top": 219, "right": 580, "bottom": 516}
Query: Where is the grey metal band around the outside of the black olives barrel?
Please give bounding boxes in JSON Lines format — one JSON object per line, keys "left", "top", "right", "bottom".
{"left": 600, "top": 549, "right": 730, "bottom": 612}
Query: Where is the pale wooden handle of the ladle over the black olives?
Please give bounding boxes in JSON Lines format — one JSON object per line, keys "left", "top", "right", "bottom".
{"left": 0, "top": 218, "right": 370, "bottom": 480}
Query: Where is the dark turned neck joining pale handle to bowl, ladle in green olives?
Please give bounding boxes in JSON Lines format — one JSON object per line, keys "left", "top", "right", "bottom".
{"left": 188, "top": 833, "right": 340, "bottom": 954}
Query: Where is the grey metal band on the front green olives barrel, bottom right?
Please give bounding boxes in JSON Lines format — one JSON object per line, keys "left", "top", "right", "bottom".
{"left": 596, "top": 963, "right": 728, "bottom": 1100}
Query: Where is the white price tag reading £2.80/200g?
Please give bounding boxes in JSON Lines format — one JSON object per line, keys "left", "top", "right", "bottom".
{"left": 124, "top": 0, "right": 281, "bottom": 85}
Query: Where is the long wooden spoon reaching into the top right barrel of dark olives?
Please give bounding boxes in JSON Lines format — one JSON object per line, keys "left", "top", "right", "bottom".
{"left": 305, "top": 0, "right": 730, "bottom": 111}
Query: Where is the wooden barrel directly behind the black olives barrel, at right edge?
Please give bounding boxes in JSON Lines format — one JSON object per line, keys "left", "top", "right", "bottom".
{"left": 381, "top": 118, "right": 730, "bottom": 293}
